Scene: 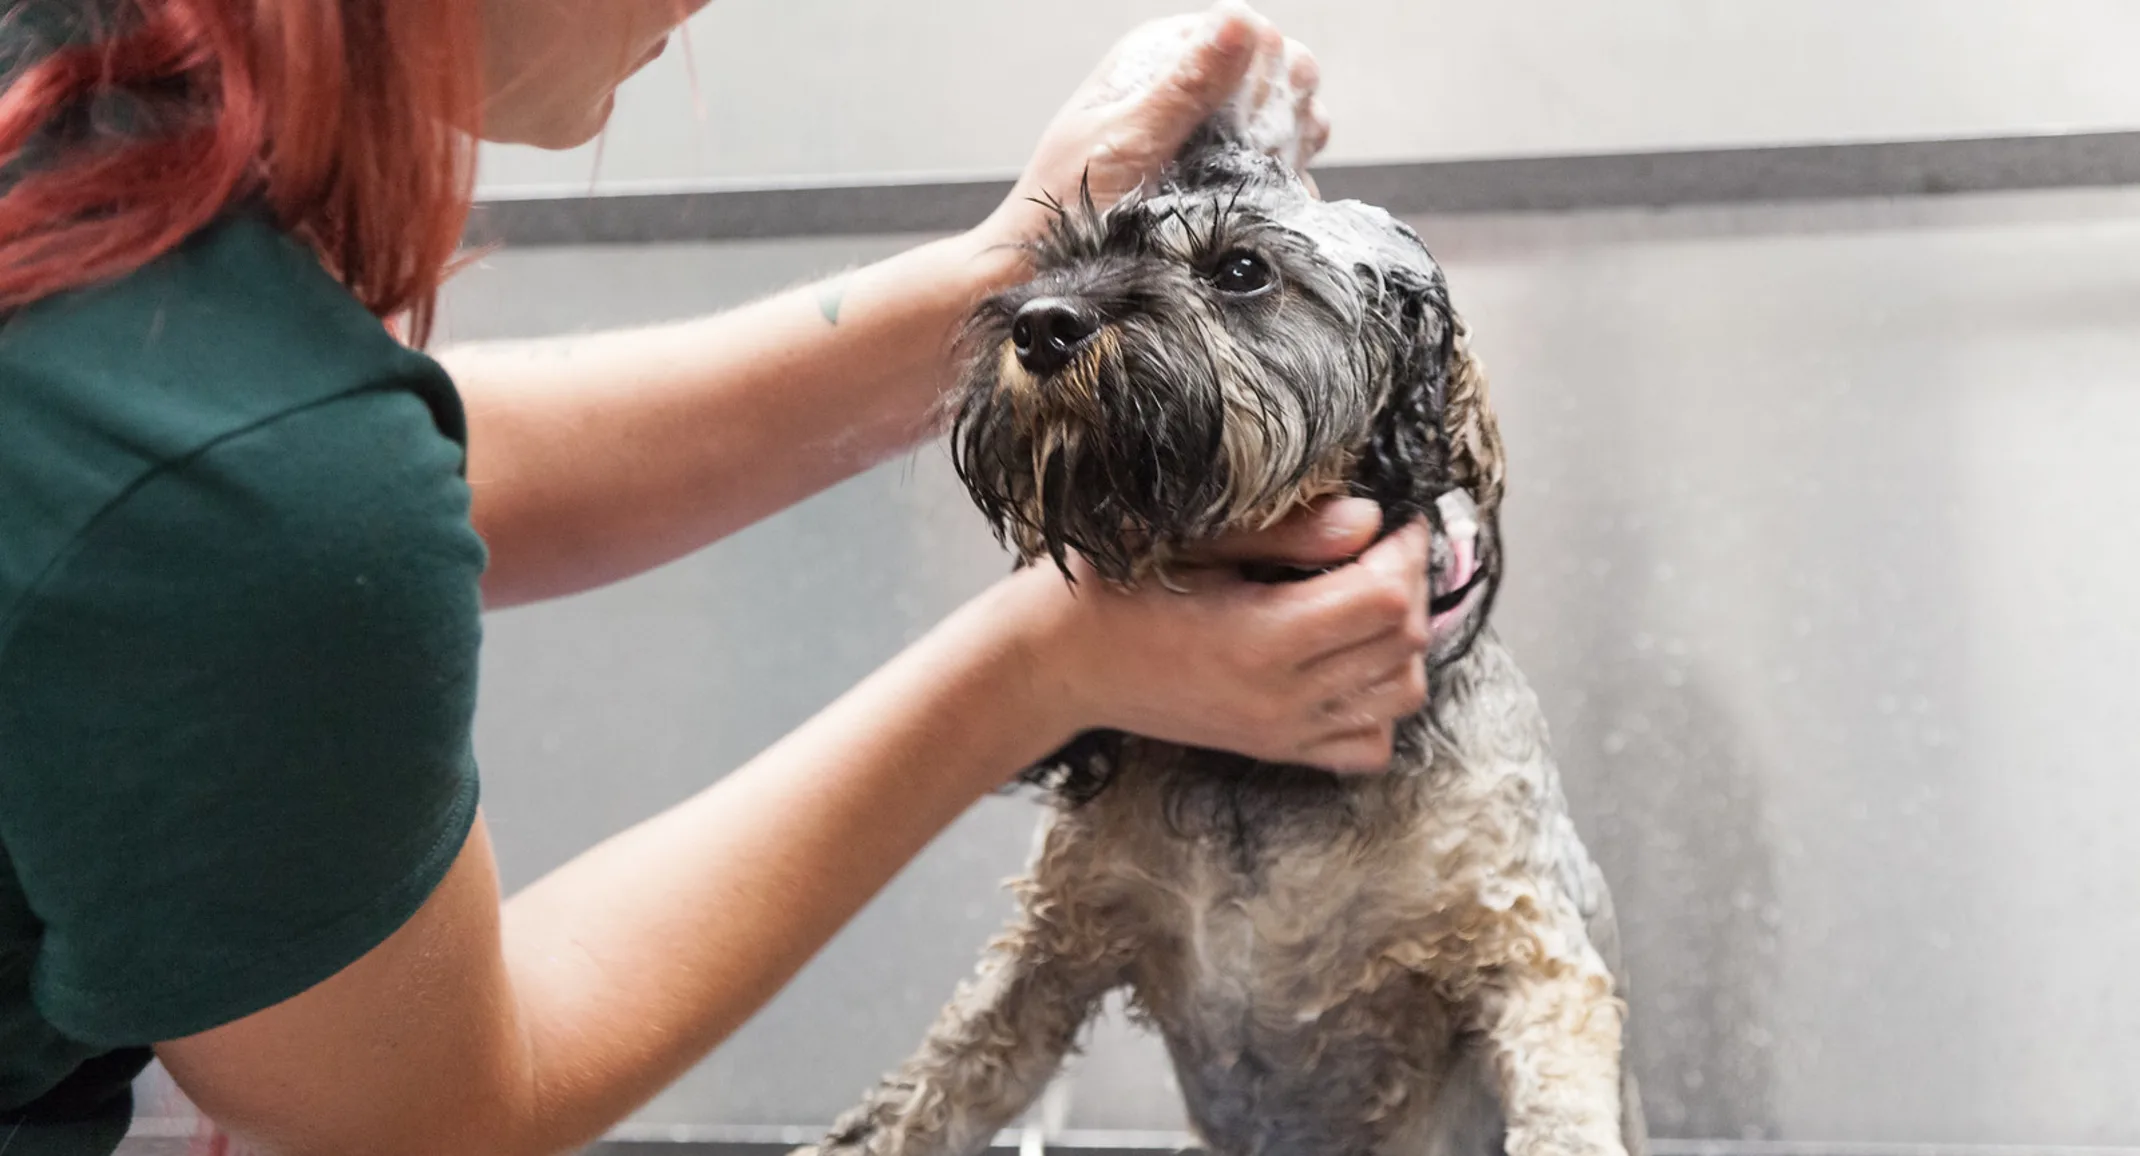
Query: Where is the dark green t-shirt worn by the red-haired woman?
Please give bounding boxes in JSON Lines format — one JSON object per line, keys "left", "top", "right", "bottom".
{"left": 0, "top": 214, "right": 486, "bottom": 1156}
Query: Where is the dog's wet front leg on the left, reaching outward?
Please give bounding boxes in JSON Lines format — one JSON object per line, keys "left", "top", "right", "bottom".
{"left": 798, "top": 908, "right": 1121, "bottom": 1156}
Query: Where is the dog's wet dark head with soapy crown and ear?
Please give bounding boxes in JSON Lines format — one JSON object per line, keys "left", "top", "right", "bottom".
{"left": 952, "top": 137, "right": 1500, "bottom": 664}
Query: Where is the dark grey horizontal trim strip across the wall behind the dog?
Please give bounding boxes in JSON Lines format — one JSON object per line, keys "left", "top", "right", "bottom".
{"left": 469, "top": 131, "right": 2140, "bottom": 244}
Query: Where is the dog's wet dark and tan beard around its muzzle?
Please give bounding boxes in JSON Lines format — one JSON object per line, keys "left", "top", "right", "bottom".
{"left": 952, "top": 293, "right": 1380, "bottom": 582}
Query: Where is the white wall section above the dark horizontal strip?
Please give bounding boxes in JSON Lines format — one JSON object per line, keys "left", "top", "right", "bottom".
{"left": 486, "top": 0, "right": 2140, "bottom": 191}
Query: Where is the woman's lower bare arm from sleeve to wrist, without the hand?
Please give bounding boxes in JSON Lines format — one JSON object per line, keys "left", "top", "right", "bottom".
{"left": 158, "top": 569, "right": 1061, "bottom": 1156}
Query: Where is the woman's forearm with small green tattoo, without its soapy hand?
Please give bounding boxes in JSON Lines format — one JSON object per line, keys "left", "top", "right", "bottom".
{"left": 441, "top": 225, "right": 1021, "bottom": 606}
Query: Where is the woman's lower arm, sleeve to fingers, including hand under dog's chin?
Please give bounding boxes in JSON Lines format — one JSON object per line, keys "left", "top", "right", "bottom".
{"left": 156, "top": 513, "right": 1425, "bottom": 1156}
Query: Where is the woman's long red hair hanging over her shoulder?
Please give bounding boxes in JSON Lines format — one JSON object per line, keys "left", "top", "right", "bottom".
{"left": 0, "top": 0, "right": 482, "bottom": 345}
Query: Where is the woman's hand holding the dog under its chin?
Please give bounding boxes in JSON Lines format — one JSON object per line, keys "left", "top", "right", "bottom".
{"left": 1006, "top": 499, "right": 1427, "bottom": 771}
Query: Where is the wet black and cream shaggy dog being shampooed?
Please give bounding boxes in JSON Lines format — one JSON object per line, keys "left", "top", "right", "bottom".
{"left": 803, "top": 120, "right": 1646, "bottom": 1156}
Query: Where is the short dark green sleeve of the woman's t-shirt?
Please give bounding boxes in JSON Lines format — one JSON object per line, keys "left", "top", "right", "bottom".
{"left": 0, "top": 390, "right": 484, "bottom": 1047}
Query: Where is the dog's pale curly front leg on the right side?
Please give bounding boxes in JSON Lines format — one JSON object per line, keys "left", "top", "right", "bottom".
{"left": 1474, "top": 936, "right": 1626, "bottom": 1156}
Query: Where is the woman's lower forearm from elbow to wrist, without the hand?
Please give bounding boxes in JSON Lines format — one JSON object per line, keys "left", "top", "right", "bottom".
{"left": 505, "top": 582, "right": 1070, "bottom": 1152}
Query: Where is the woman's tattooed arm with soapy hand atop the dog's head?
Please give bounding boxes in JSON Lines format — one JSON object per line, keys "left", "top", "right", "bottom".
{"left": 441, "top": 6, "right": 1325, "bottom": 606}
